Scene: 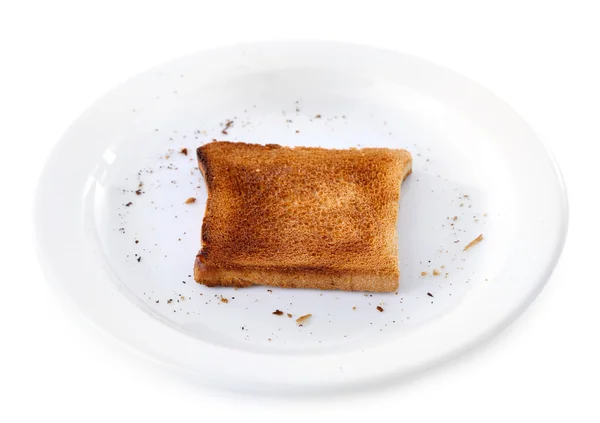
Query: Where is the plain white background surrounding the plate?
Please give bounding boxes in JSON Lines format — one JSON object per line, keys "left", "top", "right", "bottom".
{"left": 0, "top": 0, "right": 600, "bottom": 422}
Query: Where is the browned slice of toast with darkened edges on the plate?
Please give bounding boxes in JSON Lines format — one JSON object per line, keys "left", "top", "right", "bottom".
{"left": 194, "top": 141, "right": 412, "bottom": 292}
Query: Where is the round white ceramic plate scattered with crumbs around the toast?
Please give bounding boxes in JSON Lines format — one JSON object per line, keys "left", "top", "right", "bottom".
{"left": 35, "top": 43, "right": 567, "bottom": 392}
